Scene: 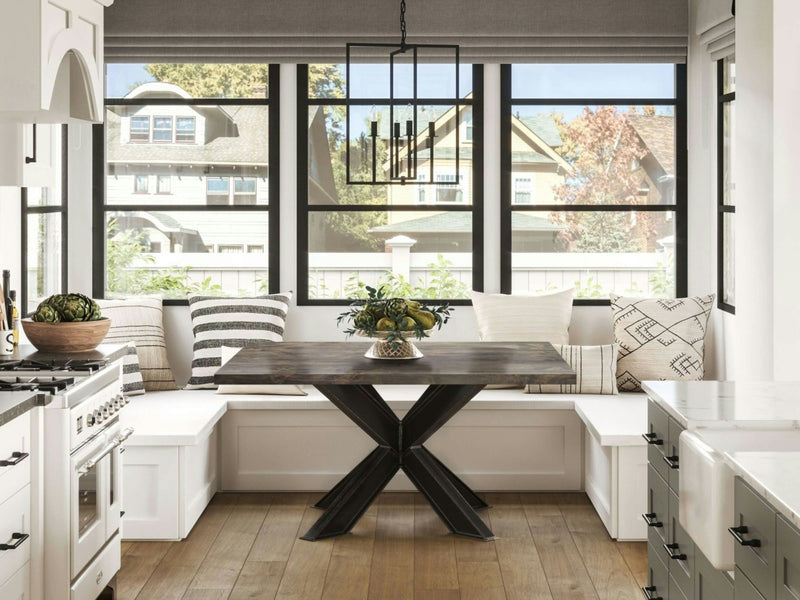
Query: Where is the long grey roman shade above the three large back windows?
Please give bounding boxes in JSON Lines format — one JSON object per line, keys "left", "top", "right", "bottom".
{"left": 105, "top": 0, "right": 689, "bottom": 63}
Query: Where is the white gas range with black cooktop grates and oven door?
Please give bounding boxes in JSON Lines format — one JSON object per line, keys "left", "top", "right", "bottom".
{"left": 0, "top": 352, "right": 133, "bottom": 600}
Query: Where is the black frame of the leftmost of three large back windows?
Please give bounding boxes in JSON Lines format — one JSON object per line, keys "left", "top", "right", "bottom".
{"left": 92, "top": 64, "right": 281, "bottom": 306}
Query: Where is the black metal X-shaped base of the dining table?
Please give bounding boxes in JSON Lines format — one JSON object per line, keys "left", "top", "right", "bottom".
{"left": 302, "top": 385, "right": 494, "bottom": 541}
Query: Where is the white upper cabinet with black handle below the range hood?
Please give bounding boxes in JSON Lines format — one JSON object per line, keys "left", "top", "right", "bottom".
{"left": 0, "top": 122, "right": 61, "bottom": 187}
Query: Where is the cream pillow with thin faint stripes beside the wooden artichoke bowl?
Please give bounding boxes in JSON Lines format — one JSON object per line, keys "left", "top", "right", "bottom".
{"left": 97, "top": 296, "right": 178, "bottom": 392}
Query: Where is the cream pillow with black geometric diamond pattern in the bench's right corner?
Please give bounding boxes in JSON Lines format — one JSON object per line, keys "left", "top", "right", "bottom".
{"left": 611, "top": 294, "right": 714, "bottom": 392}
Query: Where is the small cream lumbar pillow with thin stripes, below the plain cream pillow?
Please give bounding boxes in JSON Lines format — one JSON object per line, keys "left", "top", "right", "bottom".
{"left": 525, "top": 344, "right": 619, "bottom": 394}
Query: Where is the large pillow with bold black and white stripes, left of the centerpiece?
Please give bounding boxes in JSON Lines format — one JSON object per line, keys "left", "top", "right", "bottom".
{"left": 184, "top": 292, "right": 292, "bottom": 390}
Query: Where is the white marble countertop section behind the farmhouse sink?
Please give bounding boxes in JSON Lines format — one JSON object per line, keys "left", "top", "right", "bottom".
{"left": 642, "top": 381, "right": 800, "bottom": 429}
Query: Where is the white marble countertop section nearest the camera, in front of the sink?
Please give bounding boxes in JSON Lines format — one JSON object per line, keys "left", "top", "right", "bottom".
{"left": 725, "top": 452, "right": 800, "bottom": 528}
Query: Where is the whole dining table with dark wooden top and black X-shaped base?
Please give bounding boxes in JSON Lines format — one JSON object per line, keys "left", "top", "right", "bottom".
{"left": 214, "top": 342, "right": 576, "bottom": 541}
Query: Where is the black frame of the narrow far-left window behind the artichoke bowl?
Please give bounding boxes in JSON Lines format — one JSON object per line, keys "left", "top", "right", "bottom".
{"left": 17, "top": 124, "right": 69, "bottom": 317}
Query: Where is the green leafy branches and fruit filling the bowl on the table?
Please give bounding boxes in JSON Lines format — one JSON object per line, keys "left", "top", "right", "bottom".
{"left": 336, "top": 286, "right": 451, "bottom": 348}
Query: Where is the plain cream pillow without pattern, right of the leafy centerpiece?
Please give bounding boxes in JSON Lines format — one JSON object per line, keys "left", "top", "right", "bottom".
{"left": 472, "top": 288, "right": 575, "bottom": 344}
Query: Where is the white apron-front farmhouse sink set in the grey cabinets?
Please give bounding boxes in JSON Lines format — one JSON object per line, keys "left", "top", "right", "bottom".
{"left": 678, "top": 429, "right": 800, "bottom": 571}
